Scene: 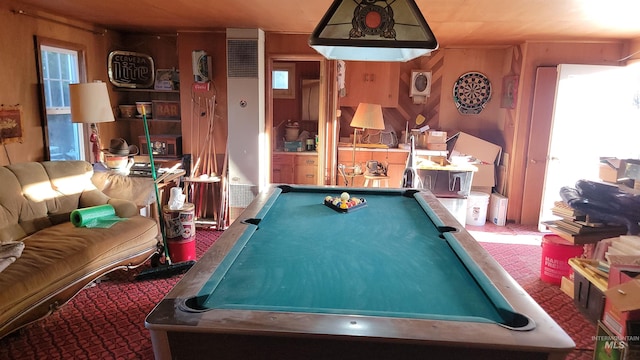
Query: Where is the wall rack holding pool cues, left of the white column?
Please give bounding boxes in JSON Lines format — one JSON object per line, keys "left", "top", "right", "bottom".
{"left": 184, "top": 83, "right": 229, "bottom": 230}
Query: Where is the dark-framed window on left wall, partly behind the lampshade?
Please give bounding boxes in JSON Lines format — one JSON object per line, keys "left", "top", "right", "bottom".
{"left": 38, "top": 39, "right": 87, "bottom": 160}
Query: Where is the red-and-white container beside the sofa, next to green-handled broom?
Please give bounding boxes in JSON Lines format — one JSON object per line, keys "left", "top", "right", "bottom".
{"left": 162, "top": 203, "right": 196, "bottom": 262}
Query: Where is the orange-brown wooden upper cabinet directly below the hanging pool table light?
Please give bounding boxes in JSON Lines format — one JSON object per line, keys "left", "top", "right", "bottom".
{"left": 340, "top": 61, "right": 400, "bottom": 107}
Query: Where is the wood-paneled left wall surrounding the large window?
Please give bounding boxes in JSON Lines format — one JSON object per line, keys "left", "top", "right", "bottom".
{"left": 0, "top": 1, "right": 117, "bottom": 165}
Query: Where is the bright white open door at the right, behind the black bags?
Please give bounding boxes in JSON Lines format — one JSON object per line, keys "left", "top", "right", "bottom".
{"left": 540, "top": 64, "right": 640, "bottom": 228}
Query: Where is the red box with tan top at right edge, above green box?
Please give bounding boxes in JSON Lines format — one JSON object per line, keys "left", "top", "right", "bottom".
{"left": 602, "top": 278, "right": 640, "bottom": 342}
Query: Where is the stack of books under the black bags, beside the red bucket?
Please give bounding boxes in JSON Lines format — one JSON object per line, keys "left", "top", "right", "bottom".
{"left": 544, "top": 201, "right": 627, "bottom": 244}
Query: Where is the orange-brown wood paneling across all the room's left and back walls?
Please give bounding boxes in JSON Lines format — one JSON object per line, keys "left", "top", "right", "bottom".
{"left": 0, "top": 0, "right": 640, "bottom": 222}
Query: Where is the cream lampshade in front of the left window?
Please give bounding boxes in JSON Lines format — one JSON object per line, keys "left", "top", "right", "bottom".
{"left": 69, "top": 82, "right": 115, "bottom": 124}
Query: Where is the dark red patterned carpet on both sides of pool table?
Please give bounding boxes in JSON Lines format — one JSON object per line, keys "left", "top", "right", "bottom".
{"left": 0, "top": 228, "right": 596, "bottom": 360}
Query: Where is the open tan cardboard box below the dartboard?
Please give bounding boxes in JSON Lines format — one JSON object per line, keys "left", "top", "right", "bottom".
{"left": 447, "top": 132, "right": 502, "bottom": 188}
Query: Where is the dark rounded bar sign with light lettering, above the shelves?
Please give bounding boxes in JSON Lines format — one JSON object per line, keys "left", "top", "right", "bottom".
{"left": 108, "top": 50, "right": 155, "bottom": 89}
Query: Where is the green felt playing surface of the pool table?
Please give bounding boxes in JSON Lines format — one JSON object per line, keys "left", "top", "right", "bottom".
{"left": 198, "top": 188, "right": 509, "bottom": 323}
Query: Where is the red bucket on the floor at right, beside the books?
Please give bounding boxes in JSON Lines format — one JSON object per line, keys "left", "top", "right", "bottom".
{"left": 540, "top": 235, "right": 584, "bottom": 285}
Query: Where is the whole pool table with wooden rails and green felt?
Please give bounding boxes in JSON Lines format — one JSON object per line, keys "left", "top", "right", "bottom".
{"left": 145, "top": 185, "right": 575, "bottom": 360}
